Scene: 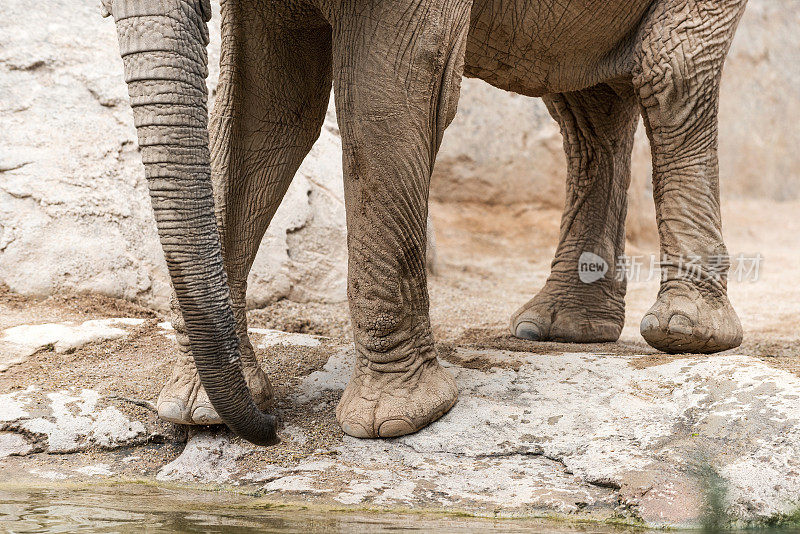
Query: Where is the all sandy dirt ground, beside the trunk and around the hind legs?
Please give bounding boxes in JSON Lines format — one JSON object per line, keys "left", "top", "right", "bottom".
{"left": 0, "top": 201, "right": 800, "bottom": 399}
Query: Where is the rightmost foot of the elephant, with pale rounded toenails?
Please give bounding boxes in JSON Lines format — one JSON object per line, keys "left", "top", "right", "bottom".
{"left": 640, "top": 280, "right": 742, "bottom": 354}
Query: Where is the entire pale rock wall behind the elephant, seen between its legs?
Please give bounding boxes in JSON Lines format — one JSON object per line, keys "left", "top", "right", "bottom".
{"left": 0, "top": 0, "right": 800, "bottom": 309}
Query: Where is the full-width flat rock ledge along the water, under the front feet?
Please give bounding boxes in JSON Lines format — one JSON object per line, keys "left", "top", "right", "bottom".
{"left": 0, "top": 318, "right": 800, "bottom": 526}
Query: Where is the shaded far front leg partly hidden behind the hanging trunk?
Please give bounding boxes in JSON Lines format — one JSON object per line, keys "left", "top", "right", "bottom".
{"left": 158, "top": 0, "right": 331, "bottom": 424}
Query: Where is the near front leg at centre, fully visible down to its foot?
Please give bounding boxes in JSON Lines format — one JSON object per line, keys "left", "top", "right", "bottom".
{"left": 333, "top": 0, "right": 470, "bottom": 438}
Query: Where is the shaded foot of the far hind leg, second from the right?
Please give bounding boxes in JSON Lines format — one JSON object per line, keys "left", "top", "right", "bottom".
{"left": 511, "top": 281, "right": 625, "bottom": 343}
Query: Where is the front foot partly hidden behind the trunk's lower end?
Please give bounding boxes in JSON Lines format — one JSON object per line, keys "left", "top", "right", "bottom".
{"left": 156, "top": 357, "right": 273, "bottom": 425}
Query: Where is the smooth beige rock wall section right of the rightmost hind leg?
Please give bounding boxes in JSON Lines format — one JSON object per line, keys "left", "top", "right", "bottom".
{"left": 720, "top": 0, "right": 800, "bottom": 201}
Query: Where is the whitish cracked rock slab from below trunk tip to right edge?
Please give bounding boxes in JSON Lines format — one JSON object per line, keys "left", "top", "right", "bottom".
{"left": 145, "top": 335, "right": 800, "bottom": 526}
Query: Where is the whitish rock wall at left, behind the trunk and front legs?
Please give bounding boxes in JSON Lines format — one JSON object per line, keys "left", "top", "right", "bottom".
{"left": 0, "top": 0, "right": 347, "bottom": 310}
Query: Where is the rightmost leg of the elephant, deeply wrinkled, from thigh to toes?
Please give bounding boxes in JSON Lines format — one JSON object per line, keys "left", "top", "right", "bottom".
{"left": 634, "top": 0, "right": 746, "bottom": 353}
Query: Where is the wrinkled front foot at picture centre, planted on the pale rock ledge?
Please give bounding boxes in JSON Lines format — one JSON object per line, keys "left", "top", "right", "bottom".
{"left": 336, "top": 358, "right": 458, "bottom": 438}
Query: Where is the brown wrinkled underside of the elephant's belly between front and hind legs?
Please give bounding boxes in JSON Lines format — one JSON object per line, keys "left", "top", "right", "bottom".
{"left": 464, "top": 0, "right": 653, "bottom": 96}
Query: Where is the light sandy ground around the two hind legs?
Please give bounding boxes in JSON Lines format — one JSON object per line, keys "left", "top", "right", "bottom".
{"left": 430, "top": 200, "right": 800, "bottom": 373}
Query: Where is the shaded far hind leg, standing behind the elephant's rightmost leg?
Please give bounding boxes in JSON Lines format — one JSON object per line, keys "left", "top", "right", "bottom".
{"left": 511, "top": 82, "right": 638, "bottom": 343}
